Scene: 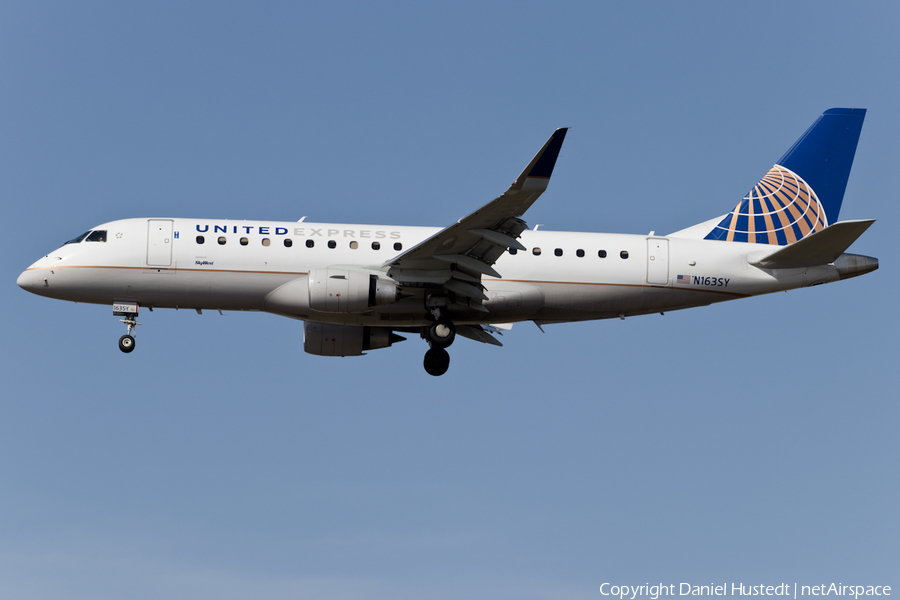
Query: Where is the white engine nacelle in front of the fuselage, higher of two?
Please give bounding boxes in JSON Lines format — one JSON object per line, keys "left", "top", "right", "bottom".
{"left": 308, "top": 267, "right": 397, "bottom": 313}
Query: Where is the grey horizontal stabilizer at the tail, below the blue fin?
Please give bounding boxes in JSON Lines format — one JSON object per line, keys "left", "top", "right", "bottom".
{"left": 750, "top": 219, "right": 875, "bottom": 269}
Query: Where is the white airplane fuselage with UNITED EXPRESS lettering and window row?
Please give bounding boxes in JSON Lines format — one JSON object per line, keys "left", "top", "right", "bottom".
{"left": 18, "top": 218, "right": 841, "bottom": 327}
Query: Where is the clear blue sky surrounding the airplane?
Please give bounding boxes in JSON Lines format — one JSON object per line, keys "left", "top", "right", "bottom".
{"left": 0, "top": 2, "right": 900, "bottom": 599}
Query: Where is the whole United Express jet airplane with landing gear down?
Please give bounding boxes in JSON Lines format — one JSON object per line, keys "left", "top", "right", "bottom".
{"left": 17, "top": 108, "right": 878, "bottom": 376}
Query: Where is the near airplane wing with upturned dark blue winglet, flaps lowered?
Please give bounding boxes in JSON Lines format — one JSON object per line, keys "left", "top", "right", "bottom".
{"left": 382, "top": 128, "right": 568, "bottom": 311}
